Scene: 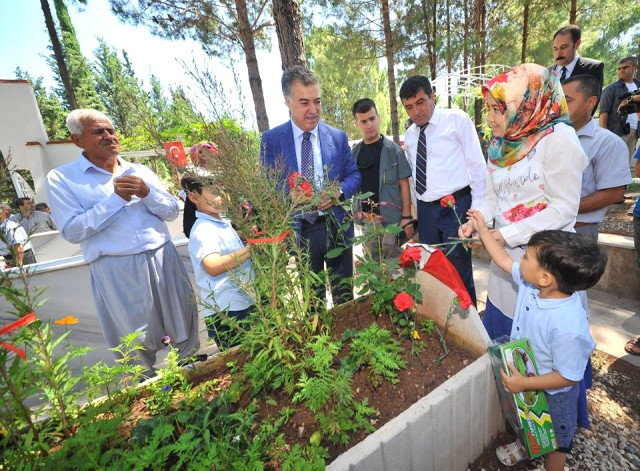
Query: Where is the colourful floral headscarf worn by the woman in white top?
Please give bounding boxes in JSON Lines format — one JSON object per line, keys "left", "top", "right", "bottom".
{"left": 482, "top": 64, "right": 571, "bottom": 167}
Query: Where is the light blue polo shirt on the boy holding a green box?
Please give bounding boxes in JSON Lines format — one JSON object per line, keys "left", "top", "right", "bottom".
{"left": 511, "top": 262, "right": 596, "bottom": 394}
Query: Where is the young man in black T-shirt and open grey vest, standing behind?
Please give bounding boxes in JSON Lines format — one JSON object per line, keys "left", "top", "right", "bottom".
{"left": 351, "top": 98, "right": 413, "bottom": 260}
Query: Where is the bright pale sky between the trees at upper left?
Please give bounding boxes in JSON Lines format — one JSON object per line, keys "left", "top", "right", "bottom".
{"left": 0, "top": 0, "right": 289, "bottom": 128}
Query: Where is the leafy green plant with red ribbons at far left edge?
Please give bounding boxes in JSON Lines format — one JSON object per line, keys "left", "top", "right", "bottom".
{"left": 0, "top": 258, "right": 87, "bottom": 468}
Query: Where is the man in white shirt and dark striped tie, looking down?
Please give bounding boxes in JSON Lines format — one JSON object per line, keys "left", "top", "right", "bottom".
{"left": 400, "top": 75, "right": 486, "bottom": 304}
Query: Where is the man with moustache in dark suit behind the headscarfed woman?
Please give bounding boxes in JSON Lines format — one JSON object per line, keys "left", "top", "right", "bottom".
{"left": 549, "top": 25, "right": 604, "bottom": 116}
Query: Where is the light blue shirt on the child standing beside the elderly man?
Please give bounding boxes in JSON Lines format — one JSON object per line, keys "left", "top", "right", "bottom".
{"left": 189, "top": 211, "right": 253, "bottom": 317}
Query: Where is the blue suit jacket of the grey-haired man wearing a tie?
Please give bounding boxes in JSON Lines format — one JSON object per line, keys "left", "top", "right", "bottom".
{"left": 260, "top": 121, "right": 360, "bottom": 236}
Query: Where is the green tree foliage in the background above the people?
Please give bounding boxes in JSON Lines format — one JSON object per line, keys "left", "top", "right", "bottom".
{"left": 6, "top": 0, "right": 640, "bottom": 150}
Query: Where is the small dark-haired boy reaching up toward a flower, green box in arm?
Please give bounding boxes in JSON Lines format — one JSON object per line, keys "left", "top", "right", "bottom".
{"left": 467, "top": 210, "right": 607, "bottom": 471}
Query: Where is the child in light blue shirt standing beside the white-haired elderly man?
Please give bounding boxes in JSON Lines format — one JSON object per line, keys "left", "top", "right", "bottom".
{"left": 181, "top": 175, "right": 253, "bottom": 349}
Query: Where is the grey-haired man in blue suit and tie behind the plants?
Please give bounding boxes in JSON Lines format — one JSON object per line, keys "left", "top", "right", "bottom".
{"left": 260, "top": 66, "right": 360, "bottom": 304}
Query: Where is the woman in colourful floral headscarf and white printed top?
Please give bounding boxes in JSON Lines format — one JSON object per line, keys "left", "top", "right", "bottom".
{"left": 460, "top": 64, "right": 587, "bottom": 338}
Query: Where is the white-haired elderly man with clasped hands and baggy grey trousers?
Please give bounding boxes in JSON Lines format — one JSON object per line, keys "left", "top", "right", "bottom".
{"left": 47, "top": 110, "right": 199, "bottom": 375}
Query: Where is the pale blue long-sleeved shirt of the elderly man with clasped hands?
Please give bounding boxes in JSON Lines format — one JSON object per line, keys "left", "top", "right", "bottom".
{"left": 47, "top": 155, "right": 179, "bottom": 262}
